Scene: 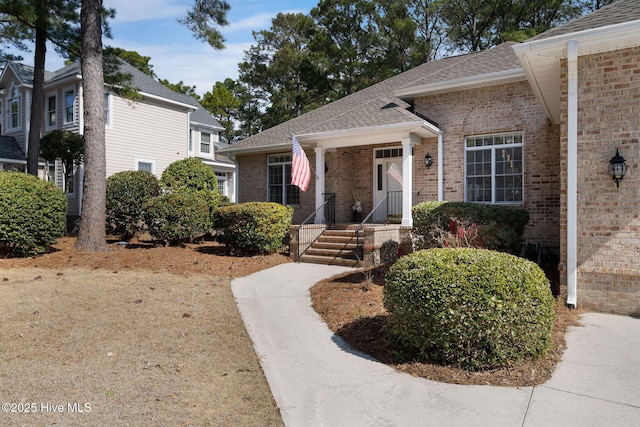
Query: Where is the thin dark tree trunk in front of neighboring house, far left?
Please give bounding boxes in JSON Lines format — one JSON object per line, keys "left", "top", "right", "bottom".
{"left": 27, "top": 0, "right": 48, "bottom": 176}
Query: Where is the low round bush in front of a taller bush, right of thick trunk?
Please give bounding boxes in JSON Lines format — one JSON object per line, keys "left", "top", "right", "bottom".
{"left": 145, "top": 191, "right": 211, "bottom": 245}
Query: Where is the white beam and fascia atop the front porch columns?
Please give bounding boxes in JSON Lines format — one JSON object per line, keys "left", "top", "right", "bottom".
{"left": 296, "top": 121, "right": 441, "bottom": 149}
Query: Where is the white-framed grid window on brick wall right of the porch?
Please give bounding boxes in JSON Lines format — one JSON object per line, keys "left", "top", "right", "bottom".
{"left": 464, "top": 133, "right": 524, "bottom": 203}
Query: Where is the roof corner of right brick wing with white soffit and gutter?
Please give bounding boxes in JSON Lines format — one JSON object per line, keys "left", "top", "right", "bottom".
{"left": 513, "top": 0, "right": 640, "bottom": 123}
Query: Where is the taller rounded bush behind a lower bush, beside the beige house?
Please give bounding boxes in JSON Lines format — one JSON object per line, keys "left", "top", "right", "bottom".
{"left": 161, "top": 157, "right": 221, "bottom": 215}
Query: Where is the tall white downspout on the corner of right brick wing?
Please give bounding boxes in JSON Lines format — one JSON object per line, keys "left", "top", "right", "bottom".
{"left": 567, "top": 40, "right": 578, "bottom": 307}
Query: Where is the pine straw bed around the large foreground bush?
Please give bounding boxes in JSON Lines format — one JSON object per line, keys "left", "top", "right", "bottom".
{"left": 311, "top": 268, "right": 581, "bottom": 387}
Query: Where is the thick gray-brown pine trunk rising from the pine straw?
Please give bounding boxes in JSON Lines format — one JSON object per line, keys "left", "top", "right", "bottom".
{"left": 76, "top": 0, "right": 107, "bottom": 252}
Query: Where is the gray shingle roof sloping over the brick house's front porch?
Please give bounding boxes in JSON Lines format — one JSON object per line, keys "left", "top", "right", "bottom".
{"left": 221, "top": 43, "right": 524, "bottom": 153}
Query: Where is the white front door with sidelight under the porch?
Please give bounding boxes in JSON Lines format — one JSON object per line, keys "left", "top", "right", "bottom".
{"left": 373, "top": 148, "right": 402, "bottom": 223}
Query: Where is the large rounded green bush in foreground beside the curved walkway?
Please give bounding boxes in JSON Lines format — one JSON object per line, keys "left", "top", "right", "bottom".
{"left": 383, "top": 248, "right": 554, "bottom": 370}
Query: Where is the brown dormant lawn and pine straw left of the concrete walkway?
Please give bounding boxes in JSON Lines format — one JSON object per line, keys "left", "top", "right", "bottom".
{"left": 0, "top": 238, "right": 289, "bottom": 426}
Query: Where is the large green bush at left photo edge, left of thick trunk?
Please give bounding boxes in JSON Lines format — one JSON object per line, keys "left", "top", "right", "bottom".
{"left": 0, "top": 172, "right": 67, "bottom": 256}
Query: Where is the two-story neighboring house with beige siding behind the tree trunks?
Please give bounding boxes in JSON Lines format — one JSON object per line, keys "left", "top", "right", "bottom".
{"left": 0, "top": 62, "right": 236, "bottom": 216}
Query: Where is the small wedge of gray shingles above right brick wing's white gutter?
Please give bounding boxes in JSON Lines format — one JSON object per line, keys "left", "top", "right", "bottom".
{"left": 527, "top": 0, "right": 640, "bottom": 41}
